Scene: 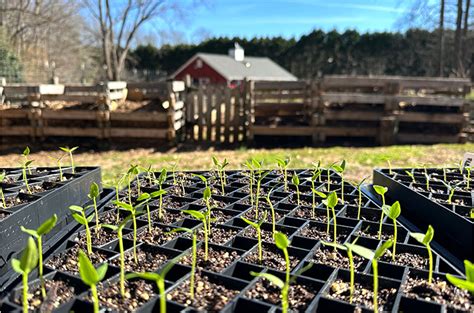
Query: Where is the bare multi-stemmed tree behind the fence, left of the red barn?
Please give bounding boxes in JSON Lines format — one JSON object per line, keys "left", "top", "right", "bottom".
{"left": 84, "top": 0, "right": 176, "bottom": 80}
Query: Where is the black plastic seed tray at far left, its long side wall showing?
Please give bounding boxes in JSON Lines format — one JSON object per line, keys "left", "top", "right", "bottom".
{"left": 0, "top": 167, "right": 101, "bottom": 284}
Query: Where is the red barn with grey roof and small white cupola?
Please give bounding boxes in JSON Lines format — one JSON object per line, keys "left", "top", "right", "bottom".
{"left": 171, "top": 43, "right": 297, "bottom": 86}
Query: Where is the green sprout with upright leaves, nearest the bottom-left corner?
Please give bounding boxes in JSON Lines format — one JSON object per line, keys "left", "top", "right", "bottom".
{"left": 12, "top": 237, "right": 38, "bottom": 313}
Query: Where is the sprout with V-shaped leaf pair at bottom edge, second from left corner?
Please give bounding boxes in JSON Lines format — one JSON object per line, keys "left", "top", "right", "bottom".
{"left": 79, "top": 250, "right": 108, "bottom": 313}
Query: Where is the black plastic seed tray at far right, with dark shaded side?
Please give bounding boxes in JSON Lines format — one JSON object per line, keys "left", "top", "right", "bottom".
{"left": 374, "top": 168, "right": 474, "bottom": 264}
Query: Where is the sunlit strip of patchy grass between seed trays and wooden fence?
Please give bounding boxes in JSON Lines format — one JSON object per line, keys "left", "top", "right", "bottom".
{"left": 0, "top": 143, "right": 474, "bottom": 185}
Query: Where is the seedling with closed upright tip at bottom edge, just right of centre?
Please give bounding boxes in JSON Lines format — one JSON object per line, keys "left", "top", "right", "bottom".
{"left": 250, "top": 232, "right": 313, "bottom": 313}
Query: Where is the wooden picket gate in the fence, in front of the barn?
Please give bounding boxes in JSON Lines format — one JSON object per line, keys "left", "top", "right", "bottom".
{"left": 186, "top": 85, "right": 247, "bottom": 144}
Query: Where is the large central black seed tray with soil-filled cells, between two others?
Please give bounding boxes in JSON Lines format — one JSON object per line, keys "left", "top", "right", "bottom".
{"left": 0, "top": 170, "right": 474, "bottom": 312}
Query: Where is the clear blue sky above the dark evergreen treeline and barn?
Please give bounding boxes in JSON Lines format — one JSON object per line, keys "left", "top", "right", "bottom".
{"left": 168, "top": 0, "right": 416, "bottom": 41}
